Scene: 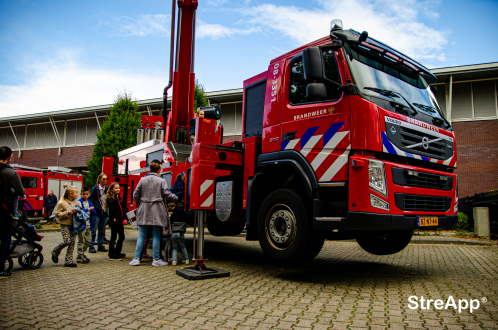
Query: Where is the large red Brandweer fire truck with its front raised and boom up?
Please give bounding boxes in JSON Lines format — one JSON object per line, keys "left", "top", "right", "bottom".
{"left": 103, "top": 0, "right": 458, "bottom": 268}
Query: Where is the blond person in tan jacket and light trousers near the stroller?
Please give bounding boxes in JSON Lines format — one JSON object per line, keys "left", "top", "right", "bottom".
{"left": 52, "top": 185, "right": 81, "bottom": 267}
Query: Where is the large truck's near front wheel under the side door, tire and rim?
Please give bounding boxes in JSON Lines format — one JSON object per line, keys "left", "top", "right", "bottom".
{"left": 258, "top": 189, "right": 325, "bottom": 264}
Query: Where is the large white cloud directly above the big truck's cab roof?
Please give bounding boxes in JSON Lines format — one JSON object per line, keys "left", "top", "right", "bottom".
{"left": 237, "top": 0, "right": 448, "bottom": 61}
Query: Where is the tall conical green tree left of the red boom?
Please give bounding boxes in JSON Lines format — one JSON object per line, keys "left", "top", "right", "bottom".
{"left": 85, "top": 90, "right": 142, "bottom": 187}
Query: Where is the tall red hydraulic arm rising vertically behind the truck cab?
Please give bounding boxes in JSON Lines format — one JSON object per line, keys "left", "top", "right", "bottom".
{"left": 165, "top": 0, "right": 198, "bottom": 144}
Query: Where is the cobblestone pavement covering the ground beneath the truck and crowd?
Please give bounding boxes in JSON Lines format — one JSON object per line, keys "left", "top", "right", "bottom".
{"left": 0, "top": 230, "right": 498, "bottom": 329}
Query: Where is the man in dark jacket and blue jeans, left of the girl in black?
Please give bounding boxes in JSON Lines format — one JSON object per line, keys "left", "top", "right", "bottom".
{"left": 88, "top": 173, "right": 108, "bottom": 253}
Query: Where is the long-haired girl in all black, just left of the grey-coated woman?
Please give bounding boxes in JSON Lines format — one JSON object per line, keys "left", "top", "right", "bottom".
{"left": 104, "top": 182, "right": 126, "bottom": 260}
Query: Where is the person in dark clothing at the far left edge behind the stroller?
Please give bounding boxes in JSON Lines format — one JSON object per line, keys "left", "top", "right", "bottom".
{"left": 0, "top": 147, "right": 25, "bottom": 279}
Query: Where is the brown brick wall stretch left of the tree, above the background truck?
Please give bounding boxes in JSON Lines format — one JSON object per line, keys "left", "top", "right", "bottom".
{"left": 12, "top": 146, "right": 93, "bottom": 168}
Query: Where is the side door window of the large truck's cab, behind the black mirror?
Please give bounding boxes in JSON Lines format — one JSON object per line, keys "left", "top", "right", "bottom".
{"left": 289, "top": 49, "right": 341, "bottom": 104}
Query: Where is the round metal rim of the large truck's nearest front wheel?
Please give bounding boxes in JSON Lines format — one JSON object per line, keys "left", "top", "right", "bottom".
{"left": 265, "top": 204, "right": 297, "bottom": 250}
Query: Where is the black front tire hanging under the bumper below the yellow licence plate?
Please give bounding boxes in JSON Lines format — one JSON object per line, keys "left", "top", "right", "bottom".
{"left": 356, "top": 230, "right": 413, "bottom": 256}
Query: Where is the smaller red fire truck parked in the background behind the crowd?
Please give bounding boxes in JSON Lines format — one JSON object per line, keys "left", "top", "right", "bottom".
{"left": 12, "top": 164, "right": 83, "bottom": 217}
